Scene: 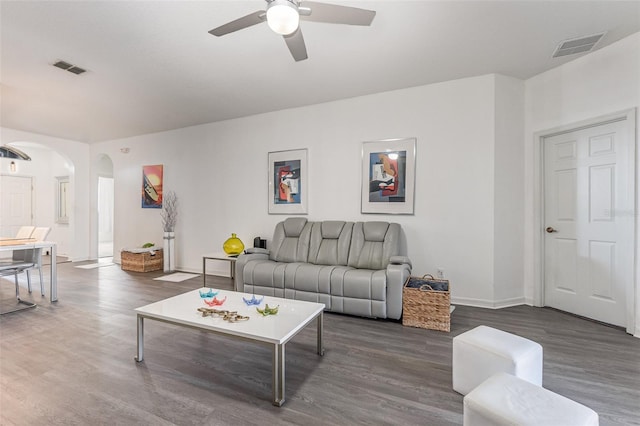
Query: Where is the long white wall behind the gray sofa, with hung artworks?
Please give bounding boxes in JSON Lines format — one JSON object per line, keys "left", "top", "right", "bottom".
{"left": 91, "top": 75, "right": 522, "bottom": 306}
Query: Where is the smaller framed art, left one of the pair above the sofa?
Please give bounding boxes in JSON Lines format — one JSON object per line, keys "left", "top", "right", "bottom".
{"left": 269, "top": 149, "right": 309, "bottom": 214}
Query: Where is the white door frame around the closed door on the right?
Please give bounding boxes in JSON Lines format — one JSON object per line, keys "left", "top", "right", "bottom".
{"left": 532, "top": 108, "right": 640, "bottom": 337}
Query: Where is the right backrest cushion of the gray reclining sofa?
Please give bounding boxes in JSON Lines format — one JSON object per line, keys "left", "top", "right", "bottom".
{"left": 348, "top": 222, "right": 400, "bottom": 269}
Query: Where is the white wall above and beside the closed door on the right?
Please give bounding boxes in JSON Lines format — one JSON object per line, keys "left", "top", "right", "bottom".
{"left": 524, "top": 33, "right": 640, "bottom": 335}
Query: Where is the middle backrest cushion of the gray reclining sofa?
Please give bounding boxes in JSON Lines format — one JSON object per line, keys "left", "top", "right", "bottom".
{"left": 309, "top": 220, "right": 353, "bottom": 266}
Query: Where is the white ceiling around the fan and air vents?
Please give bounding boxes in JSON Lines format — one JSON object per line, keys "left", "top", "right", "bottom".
{"left": 0, "top": 0, "right": 640, "bottom": 142}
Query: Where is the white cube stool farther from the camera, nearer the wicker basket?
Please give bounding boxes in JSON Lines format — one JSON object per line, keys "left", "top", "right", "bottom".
{"left": 452, "top": 325, "right": 542, "bottom": 395}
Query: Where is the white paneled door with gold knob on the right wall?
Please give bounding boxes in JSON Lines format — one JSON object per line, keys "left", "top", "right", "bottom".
{"left": 544, "top": 121, "right": 634, "bottom": 327}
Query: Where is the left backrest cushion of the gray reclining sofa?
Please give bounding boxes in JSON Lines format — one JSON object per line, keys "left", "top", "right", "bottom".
{"left": 269, "top": 217, "right": 311, "bottom": 262}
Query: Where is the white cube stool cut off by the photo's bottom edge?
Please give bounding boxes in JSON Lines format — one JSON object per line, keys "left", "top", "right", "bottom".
{"left": 463, "top": 373, "right": 599, "bottom": 426}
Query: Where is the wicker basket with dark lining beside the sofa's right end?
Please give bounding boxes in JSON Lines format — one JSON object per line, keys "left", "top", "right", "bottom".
{"left": 402, "top": 274, "right": 451, "bottom": 331}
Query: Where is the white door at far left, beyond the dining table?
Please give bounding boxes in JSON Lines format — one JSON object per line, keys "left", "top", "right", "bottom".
{"left": 0, "top": 175, "right": 33, "bottom": 237}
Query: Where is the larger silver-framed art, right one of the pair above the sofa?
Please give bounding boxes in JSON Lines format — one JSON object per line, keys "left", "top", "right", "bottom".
{"left": 361, "top": 138, "right": 416, "bottom": 214}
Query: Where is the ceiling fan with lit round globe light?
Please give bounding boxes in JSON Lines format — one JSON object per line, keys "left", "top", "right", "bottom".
{"left": 209, "top": 0, "right": 376, "bottom": 61}
